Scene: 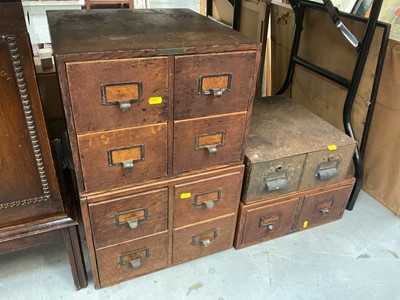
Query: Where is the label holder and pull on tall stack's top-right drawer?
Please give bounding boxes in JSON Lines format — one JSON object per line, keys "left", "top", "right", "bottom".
{"left": 197, "top": 73, "right": 232, "bottom": 98}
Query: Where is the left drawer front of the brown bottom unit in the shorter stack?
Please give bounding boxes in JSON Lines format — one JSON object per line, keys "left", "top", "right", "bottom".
{"left": 241, "top": 198, "right": 299, "bottom": 244}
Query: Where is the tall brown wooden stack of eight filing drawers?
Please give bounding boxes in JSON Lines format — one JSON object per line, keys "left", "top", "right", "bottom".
{"left": 48, "top": 10, "right": 260, "bottom": 288}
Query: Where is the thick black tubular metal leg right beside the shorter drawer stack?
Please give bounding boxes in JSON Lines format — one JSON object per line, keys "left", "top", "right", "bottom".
{"left": 343, "top": 0, "right": 382, "bottom": 210}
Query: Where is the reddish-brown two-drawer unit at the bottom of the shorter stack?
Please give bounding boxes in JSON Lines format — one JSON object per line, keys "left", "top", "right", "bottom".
{"left": 234, "top": 178, "right": 355, "bottom": 249}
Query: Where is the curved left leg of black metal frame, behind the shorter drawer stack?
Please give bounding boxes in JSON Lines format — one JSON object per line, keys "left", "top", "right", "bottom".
{"left": 276, "top": 1, "right": 304, "bottom": 95}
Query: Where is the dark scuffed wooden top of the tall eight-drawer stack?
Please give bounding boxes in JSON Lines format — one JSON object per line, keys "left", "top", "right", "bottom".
{"left": 47, "top": 9, "right": 260, "bottom": 56}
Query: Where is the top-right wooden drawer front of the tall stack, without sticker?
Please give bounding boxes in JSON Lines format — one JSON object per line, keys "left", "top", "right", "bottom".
{"left": 174, "top": 51, "right": 256, "bottom": 120}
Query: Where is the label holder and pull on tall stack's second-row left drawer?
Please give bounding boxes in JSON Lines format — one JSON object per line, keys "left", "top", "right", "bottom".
{"left": 107, "top": 145, "right": 145, "bottom": 173}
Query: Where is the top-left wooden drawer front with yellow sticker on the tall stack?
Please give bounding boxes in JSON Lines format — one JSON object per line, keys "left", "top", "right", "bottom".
{"left": 66, "top": 57, "right": 168, "bottom": 133}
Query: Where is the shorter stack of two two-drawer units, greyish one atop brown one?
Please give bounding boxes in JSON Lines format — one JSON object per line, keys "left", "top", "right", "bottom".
{"left": 235, "top": 96, "right": 356, "bottom": 249}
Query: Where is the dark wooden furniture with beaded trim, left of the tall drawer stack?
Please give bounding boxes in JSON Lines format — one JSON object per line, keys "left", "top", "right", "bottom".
{"left": 0, "top": 1, "right": 87, "bottom": 289}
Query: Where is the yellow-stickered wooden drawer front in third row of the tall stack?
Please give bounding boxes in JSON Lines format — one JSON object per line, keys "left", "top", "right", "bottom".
{"left": 174, "top": 171, "right": 243, "bottom": 227}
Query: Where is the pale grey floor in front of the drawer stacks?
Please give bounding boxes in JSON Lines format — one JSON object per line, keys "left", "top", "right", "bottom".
{"left": 0, "top": 192, "right": 400, "bottom": 300}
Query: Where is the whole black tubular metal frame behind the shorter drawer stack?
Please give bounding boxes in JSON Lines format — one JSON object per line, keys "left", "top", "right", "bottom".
{"left": 277, "top": 0, "right": 390, "bottom": 210}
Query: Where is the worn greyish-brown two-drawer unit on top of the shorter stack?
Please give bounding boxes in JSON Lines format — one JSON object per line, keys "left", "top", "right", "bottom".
{"left": 242, "top": 96, "right": 356, "bottom": 203}
